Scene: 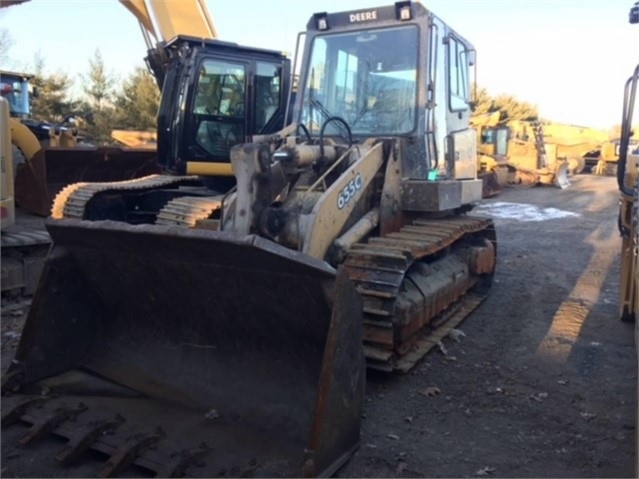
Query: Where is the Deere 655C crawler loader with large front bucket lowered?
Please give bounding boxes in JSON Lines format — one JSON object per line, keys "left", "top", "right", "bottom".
{"left": 2, "top": 1, "right": 496, "bottom": 477}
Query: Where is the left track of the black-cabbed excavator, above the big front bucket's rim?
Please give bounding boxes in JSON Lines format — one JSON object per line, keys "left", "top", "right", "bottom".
{"left": 51, "top": 175, "right": 198, "bottom": 219}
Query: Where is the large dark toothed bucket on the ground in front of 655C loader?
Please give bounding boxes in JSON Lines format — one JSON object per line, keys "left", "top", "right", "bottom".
{"left": 3, "top": 220, "right": 365, "bottom": 477}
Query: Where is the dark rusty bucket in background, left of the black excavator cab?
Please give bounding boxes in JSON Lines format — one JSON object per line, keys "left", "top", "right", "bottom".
{"left": 15, "top": 147, "right": 160, "bottom": 216}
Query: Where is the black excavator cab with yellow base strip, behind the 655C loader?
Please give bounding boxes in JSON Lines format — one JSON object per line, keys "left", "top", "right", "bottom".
{"left": 158, "top": 37, "right": 290, "bottom": 186}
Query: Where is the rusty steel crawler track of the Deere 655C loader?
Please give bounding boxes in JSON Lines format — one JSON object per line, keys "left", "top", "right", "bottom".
{"left": 344, "top": 216, "right": 496, "bottom": 372}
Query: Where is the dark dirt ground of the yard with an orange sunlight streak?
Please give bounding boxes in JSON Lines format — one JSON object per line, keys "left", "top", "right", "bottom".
{"left": 1, "top": 175, "right": 637, "bottom": 477}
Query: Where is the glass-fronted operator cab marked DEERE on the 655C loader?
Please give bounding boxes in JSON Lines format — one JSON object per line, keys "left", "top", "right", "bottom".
{"left": 293, "top": 1, "right": 476, "bottom": 179}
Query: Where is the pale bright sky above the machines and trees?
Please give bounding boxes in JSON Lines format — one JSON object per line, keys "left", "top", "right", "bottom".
{"left": 0, "top": 0, "right": 639, "bottom": 129}
